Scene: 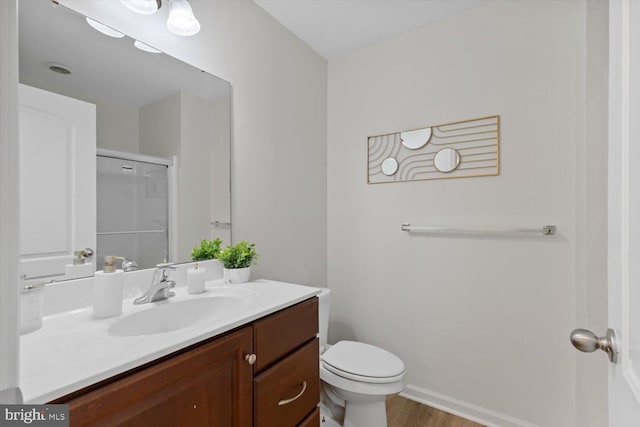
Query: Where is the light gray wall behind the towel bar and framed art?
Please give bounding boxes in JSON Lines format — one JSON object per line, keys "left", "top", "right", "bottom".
{"left": 327, "top": 0, "right": 607, "bottom": 426}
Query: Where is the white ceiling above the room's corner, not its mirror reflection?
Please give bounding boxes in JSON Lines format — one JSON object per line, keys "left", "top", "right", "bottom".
{"left": 254, "top": 0, "right": 490, "bottom": 58}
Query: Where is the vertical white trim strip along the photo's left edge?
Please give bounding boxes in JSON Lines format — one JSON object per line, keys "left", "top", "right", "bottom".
{"left": 0, "top": 0, "right": 20, "bottom": 403}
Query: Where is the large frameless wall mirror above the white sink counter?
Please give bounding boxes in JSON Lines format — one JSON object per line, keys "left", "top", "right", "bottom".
{"left": 19, "top": 0, "right": 231, "bottom": 280}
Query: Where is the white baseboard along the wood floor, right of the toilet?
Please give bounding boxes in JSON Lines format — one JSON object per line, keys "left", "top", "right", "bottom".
{"left": 400, "top": 384, "right": 537, "bottom": 427}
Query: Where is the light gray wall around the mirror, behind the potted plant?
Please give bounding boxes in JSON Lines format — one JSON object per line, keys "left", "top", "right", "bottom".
{"left": 61, "top": 0, "right": 327, "bottom": 285}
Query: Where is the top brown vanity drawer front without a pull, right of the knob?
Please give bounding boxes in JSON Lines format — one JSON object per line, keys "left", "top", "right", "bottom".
{"left": 253, "top": 297, "right": 318, "bottom": 373}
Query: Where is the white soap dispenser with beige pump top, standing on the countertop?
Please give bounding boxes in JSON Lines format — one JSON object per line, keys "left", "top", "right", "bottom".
{"left": 93, "top": 255, "right": 124, "bottom": 319}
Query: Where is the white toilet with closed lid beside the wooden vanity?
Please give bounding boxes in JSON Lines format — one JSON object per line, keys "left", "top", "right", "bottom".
{"left": 318, "top": 289, "right": 405, "bottom": 427}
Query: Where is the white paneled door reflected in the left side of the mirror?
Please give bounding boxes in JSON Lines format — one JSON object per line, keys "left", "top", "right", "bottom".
{"left": 18, "top": 85, "right": 96, "bottom": 279}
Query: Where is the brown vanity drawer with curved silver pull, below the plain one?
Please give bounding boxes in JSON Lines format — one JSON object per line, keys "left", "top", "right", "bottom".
{"left": 253, "top": 339, "right": 320, "bottom": 427}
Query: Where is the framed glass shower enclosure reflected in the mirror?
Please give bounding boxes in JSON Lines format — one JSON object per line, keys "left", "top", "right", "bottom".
{"left": 96, "top": 149, "right": 172, "bottom": 270}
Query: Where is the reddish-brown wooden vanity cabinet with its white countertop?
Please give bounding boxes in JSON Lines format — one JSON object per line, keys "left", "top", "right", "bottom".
{"left": 23, "top": 281, "right": 320, "bottom": 427}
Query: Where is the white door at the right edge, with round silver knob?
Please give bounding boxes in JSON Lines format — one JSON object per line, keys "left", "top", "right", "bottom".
{"left": 608, "top": 0, "right": 640, "bottom": 427}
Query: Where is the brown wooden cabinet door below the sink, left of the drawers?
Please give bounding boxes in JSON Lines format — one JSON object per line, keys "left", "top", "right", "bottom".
{"left": 67, "top": 327, "right": 252, "bottom": 427}
